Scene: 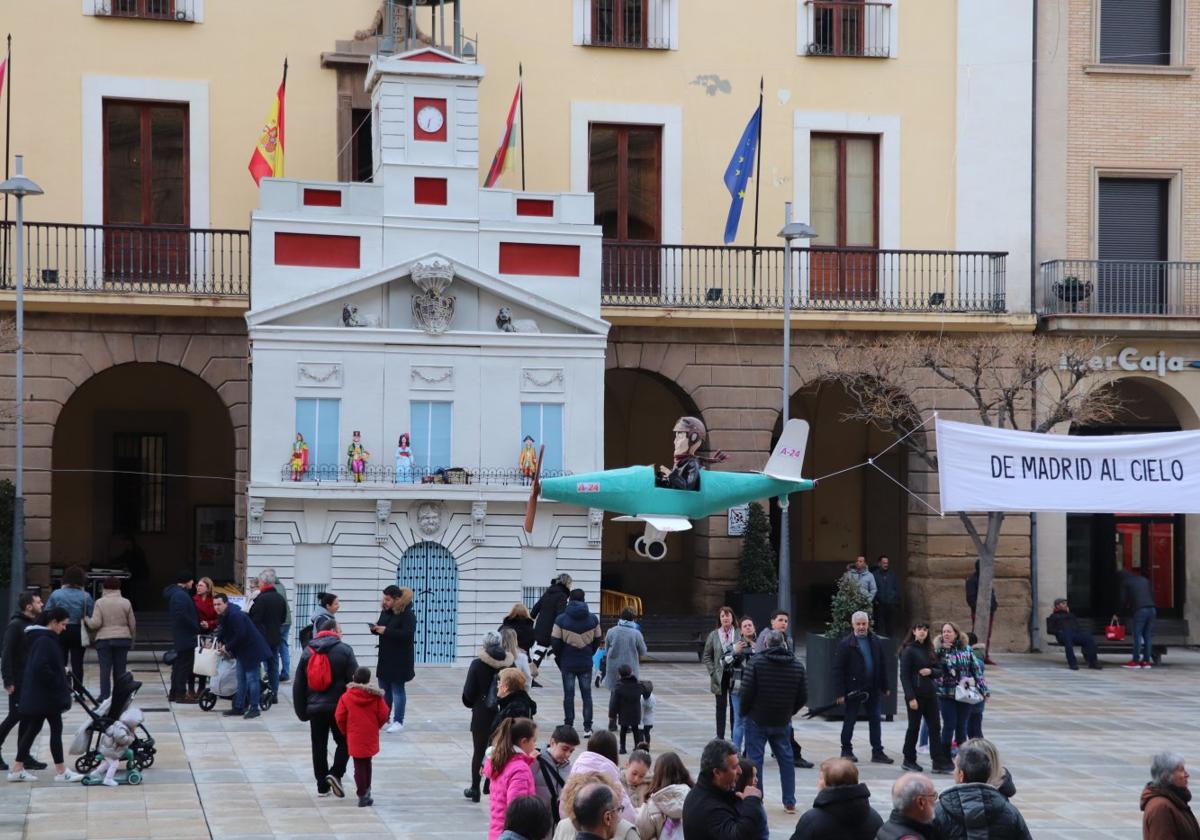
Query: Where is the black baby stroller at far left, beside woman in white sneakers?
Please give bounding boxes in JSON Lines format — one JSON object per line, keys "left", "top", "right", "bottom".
{"left": 71, "top": 671, "right": 156, "bottom": 785}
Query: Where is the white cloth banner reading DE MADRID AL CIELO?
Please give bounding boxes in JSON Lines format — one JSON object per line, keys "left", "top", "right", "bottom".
{"left": 937, "top": 418, "right": 1200, "bottom": 514}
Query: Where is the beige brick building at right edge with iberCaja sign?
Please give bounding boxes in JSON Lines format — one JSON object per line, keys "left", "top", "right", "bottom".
{"left": 1033, "top": 0, "right": 1200, "bottom": 640}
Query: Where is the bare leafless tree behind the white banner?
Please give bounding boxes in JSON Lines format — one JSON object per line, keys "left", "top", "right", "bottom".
{"left": 815, "top": 332, "right": 1122, "bottom": 648}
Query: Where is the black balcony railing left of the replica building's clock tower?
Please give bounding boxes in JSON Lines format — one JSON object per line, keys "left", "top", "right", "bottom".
{"left": 0, "top": 222, "right": 250, "bottom": 298}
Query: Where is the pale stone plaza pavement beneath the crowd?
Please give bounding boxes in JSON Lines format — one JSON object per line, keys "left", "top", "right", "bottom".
{"left": 0, "top": 650, "right": 1200, "bottom": 840}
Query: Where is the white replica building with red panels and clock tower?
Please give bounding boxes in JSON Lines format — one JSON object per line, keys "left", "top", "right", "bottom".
{"left": 246, "top": 48, "right": 607, "bottom": 662}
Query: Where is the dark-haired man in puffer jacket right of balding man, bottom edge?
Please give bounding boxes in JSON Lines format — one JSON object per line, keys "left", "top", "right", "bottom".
{"left": 934, "top": 746, "right": 1032, "bottom": 840}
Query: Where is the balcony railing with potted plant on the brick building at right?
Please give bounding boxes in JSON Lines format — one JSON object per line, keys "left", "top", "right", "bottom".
{"left": 1037, "top": 259, "right": 1200, "bottom": 318}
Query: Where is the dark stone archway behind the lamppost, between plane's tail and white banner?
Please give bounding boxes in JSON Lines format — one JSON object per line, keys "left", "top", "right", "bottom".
{"left": 770, "top": 380, "right": 908, "bottom": 629}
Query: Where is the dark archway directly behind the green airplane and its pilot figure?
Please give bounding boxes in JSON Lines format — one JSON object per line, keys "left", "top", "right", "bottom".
{"left": 600, "top": 368, "right": 703, "bottom": 613}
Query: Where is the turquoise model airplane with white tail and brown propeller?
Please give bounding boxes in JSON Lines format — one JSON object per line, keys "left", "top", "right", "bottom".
{"left": 524, "top": 420, "right": 814, "bottom": 560}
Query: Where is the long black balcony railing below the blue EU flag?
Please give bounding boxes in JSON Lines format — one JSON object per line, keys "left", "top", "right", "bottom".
{"left": 601, "top": 242, "right": 1008, "bottom": 313}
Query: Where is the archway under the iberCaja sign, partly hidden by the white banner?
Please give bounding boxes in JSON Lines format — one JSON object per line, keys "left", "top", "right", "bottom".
{"left": 1067, "top": 377, "right": 1196, "bottom": 618}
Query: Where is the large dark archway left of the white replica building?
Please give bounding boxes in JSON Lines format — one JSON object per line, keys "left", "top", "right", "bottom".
{"left": 50, "top": 362, "right": 236, "bottom": 610}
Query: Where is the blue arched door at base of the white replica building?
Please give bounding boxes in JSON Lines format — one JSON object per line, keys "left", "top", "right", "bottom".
{"left": 396, "top": 542, "right": 458, "bottom": 664}
